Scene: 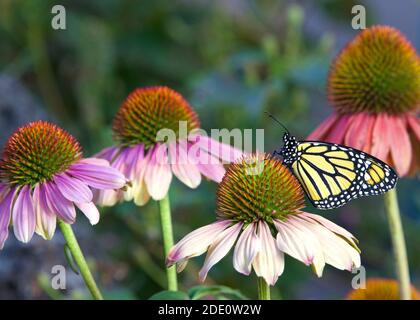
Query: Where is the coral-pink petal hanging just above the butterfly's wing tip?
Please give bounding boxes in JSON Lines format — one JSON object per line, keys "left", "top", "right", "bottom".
{"left": 388, "top": 116, "right": 413, "bottom": 177}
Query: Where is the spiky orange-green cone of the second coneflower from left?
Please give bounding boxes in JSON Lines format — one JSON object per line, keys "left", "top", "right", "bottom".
{"left": 113, "top": 87, "right": 200, "bottom": 148}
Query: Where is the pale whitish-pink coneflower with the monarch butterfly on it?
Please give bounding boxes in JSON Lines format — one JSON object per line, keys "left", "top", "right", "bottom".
{"left": 166, "top": 154, "right": 360, "bottom": 298}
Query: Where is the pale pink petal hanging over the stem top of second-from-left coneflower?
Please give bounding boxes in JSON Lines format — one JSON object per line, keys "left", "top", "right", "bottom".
{"left": 144, "top": 145, "right": 172, "bottom": 200}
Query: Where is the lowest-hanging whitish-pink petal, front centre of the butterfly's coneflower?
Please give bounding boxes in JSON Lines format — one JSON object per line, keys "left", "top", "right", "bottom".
{"left": 252, "top": 221, "right": 284, "bottom": 286}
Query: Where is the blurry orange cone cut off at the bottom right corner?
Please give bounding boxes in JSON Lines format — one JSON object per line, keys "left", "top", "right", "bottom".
{"left": 347, "top": 278, "right": 420, "bottom": 300}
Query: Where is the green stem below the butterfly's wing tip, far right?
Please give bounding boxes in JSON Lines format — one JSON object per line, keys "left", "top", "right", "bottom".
{"left": 384, "top": 189, "right": 411, "bottom": 300}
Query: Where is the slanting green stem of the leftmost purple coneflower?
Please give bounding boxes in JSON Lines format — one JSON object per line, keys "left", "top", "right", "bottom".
{"left": 58, "top": 220, "right": 103, "bottom": 300}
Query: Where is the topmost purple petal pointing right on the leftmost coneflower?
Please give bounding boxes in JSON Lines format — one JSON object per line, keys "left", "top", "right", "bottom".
{"left": 67, "top": 159, "right": 126, "bottom": 189}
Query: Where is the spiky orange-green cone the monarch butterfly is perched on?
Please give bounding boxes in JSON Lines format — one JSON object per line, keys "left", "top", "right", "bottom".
{"left": 216, "top": 154, "right": 304, "bottom": 224}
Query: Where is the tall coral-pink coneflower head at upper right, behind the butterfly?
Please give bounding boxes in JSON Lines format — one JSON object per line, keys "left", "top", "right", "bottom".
{"left": 308, "top": 26, "right": 420, "bottom": 176}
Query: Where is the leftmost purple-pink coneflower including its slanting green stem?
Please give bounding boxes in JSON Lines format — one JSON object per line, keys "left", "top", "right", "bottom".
{"left": 0, "top": 121, "right": 126, "bottom": 298}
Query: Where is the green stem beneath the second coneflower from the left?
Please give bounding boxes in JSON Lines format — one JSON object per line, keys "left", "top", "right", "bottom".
{"left": 159, "top": 195, "right": 178, "bottom": 291}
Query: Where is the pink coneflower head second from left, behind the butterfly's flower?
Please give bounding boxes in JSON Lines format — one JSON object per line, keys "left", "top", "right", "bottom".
{"left": 97, "top": 87, "right": 242, "bottom": 206}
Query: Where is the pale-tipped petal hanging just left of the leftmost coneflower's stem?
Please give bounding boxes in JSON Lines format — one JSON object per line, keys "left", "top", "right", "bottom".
{"left": 32, "top": 184, "right": 57, "bottom": 240}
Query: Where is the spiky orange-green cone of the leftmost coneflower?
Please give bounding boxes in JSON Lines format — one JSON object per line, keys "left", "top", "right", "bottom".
{"left": 0, "top": 121, "right": 82, "bottom": 186}
